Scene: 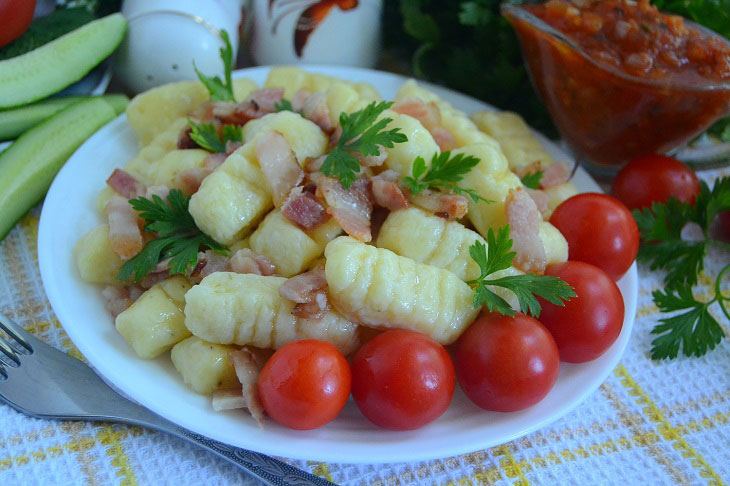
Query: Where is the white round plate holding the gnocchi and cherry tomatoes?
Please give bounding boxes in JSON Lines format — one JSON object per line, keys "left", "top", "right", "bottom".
{"left": 38, "top": 66, "right": 638, "bottom": 463}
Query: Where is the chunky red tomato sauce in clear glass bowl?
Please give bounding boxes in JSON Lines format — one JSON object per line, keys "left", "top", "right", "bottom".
{"left": 502, "top": 0, "right": 730, "bottom": 168}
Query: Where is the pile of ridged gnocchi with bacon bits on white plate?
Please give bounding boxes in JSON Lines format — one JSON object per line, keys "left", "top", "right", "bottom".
{"left": 74, "top": 67, "right": 575, "bottom": 420}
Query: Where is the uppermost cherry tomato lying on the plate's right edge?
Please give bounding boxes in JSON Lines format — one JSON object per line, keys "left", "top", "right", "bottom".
{"left": 550, "top": 193, "right": 639, "bottom": 280}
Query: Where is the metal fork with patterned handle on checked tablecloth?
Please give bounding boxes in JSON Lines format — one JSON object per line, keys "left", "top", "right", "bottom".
{"left": 0, "top": 313, "right": 334, "bottom": 486}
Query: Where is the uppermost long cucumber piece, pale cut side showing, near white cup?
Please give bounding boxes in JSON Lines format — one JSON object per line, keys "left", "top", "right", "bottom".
{"left": 0, "top": 13, "right": 127, "bottom": 108}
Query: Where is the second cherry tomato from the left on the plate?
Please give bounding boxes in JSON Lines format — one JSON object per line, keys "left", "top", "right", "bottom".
{"left": 352, "top": 329, "right": 455, "bottom": 430}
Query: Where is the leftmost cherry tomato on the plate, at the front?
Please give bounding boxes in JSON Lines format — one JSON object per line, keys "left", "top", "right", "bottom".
{"left": 258, "top": 339, "right": 351, "bottom": 430}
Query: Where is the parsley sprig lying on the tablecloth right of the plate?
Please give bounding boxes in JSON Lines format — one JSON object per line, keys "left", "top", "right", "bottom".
{"left": 633, "top": 177, "right": 730, "bottom": 359}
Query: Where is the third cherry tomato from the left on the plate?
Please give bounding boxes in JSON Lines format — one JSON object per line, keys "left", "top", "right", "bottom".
{"left": 454, "top": 313, "right": 560, "bottom": 412}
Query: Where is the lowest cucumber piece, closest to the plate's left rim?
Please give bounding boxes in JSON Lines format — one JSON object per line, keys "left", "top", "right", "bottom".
{"left": 0, "top": 98, "right": 117, "bottom": 240}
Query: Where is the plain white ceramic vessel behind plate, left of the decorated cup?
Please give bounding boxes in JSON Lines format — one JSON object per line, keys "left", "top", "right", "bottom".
{"left": 114, "top": 0, "right": 242, "bottom": 93}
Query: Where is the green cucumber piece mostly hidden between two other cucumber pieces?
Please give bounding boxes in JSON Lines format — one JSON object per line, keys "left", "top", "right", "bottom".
{"left": 0, "top": 94, "right": 129, "bottom": 140}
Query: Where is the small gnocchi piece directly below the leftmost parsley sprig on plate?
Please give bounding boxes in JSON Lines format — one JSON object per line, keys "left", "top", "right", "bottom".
{"left": 115, "top": 275, "right": 191, "bottom": 359}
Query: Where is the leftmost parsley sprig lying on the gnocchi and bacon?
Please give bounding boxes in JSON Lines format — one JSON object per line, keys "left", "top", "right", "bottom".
{"left": 117, "top": 189, "right": 227, "bottom": 282}
